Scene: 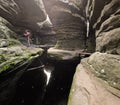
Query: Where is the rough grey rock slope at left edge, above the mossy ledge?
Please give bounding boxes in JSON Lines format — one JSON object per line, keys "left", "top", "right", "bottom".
{"left": 0, "top": 17, "right": 20, "bottom": 48}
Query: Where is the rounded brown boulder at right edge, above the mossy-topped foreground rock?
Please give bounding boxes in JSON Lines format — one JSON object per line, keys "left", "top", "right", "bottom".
{"left": 96, "top": 28, "right": 120, "bottom": 54}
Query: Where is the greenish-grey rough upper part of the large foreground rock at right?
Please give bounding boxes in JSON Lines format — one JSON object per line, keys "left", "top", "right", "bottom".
{"left": 87, "top": 52, "right": 120, "bottom": 89}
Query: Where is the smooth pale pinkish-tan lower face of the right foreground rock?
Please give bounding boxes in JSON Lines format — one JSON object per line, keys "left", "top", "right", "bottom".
{"left": 68, "top": 60, "right": 120, "bottom": 105}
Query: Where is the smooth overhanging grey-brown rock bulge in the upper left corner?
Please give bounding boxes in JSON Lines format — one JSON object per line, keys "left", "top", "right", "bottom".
{"left": 0, "top": 0, "right": 51, "bottom": 31}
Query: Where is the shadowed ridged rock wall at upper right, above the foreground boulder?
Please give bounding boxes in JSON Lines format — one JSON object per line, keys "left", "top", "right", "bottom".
{"left": 71, "top": 0, "right": 120, "bottom": 54}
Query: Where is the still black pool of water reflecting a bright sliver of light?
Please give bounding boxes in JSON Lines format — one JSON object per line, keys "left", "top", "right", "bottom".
{"left": 0, "top": 54, "right": 79, "bottom": 105}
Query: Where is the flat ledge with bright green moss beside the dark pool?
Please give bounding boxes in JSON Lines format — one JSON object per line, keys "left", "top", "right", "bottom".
{"left": 0, "top": 46, "right": 43, "bottom": 73}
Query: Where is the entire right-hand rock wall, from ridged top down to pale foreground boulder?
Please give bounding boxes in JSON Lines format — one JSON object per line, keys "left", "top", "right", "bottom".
{"left": 68, "top": 0, "right": 120, "bottom": 105}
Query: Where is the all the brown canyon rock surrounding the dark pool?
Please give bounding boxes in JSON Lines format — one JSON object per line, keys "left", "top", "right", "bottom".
{"left": 0, "top": 0, "right": 120, "bottom": 105}
